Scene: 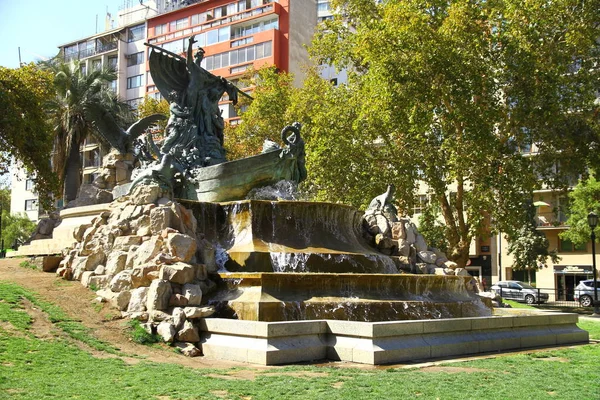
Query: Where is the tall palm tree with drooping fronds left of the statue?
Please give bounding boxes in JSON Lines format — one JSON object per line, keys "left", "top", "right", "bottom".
{"left": 46, "top": 60, "right": 131, "bottom": 205}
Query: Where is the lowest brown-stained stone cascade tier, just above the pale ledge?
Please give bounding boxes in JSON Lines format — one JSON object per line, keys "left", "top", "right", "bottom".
{"left": 209, "top": 272, "right": 491, "bottom": 322}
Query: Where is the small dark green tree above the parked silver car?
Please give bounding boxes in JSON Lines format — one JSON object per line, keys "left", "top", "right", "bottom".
{"left": 508, "top": 202, "right": 559, "bottom": 284}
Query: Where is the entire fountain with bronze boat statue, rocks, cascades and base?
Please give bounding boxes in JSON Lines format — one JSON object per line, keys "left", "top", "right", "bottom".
{"left": 35, "top": 36, "right": 588, "bottom": 364}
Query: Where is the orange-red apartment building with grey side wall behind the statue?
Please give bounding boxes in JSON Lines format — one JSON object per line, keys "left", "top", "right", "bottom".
{"left": 146, "top": 0, "right": 317, "bottom": 123}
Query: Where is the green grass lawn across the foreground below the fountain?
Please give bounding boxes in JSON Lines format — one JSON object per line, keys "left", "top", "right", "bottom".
{"left": 0, "top": 282, "right": 600, "bottom": 400}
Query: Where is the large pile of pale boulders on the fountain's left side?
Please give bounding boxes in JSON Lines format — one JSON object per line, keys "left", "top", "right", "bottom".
{"left": 57, "top": 185, "right": 217, "bottom": 355}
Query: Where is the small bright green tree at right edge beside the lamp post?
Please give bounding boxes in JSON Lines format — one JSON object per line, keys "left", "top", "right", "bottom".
{"left": 560, "top": 173, "right": 600, "bottom": 245}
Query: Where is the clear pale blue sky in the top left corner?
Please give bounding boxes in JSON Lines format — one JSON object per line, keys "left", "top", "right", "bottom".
{"left": 0, "top": 0, "right": 131, "bottom": 68}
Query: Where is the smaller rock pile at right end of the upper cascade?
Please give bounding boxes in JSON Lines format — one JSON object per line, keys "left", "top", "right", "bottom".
{"left": 363, "top": 207, "right": 468, "bottom": 276}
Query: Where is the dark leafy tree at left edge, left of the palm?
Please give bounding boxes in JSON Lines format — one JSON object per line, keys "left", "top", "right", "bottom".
{"left": 0, "top": 64, "right": 58, "bottom": 206}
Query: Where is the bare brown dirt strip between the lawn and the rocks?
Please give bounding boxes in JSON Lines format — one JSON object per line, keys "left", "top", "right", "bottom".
{"left": 0, "top": 258, "right": 268, "bottom": 370}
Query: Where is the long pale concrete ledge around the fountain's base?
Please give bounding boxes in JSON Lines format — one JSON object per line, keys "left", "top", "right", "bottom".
{"left": 200, "top": 313, "right": 589, "bottom": 365}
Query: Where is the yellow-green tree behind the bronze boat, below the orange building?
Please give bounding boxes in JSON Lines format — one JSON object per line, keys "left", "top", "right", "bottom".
{"left": 225, "top": 66, "right": 294, "bottom": 160}
